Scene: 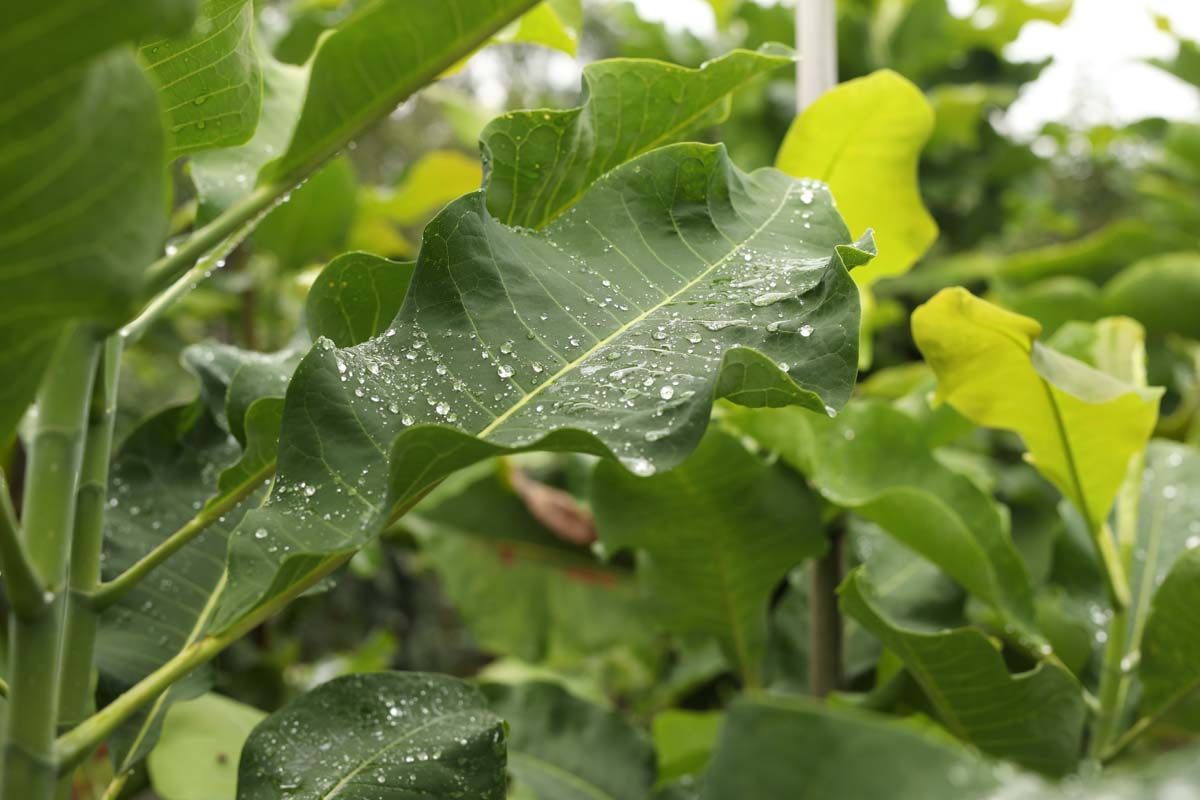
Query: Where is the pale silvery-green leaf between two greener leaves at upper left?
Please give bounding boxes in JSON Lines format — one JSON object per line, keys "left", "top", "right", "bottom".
{"left": 190, "top": 55, "right": 308, "bottom": 224}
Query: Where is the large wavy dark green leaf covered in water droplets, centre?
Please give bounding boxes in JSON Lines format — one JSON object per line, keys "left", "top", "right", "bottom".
{"left": 211, "top": 144, "right": 869, "bottom": 625}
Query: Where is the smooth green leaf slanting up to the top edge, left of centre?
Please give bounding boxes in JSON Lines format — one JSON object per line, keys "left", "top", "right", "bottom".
{"left": 265, "top": 0, "right": 544, "bottom": 182}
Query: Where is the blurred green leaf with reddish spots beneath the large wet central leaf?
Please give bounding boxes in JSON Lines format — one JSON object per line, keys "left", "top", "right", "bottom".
{"left": 415, "top": 475, "right": 658, "bottom": 669}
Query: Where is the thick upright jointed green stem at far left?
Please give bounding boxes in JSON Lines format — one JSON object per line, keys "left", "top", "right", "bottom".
{"left": 4, "top": 330, "right": 100, "bottom": 800}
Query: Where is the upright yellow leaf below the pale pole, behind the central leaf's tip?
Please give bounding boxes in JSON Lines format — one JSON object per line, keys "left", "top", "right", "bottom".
{"left": 775, "top": 70, "right": 937, "bottom": 285}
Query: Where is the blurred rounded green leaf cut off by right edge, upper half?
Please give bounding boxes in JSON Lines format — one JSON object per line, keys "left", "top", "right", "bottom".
{"left": 1102, "top": 253, "right": 1200, "bottom": 339}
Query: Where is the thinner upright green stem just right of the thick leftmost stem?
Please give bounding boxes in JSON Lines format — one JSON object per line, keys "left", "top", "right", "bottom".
{"left": 59, "top": 336, "right": 122, "bottom": 726}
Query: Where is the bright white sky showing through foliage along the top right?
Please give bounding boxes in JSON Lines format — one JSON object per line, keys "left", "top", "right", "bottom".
{"left": 634, "top": 0, "right": 1200, "bottom": 137}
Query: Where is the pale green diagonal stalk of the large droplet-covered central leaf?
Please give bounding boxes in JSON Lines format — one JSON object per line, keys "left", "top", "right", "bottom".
{"left": 55, "top": 552, "right": 353, "bottom": 772}
